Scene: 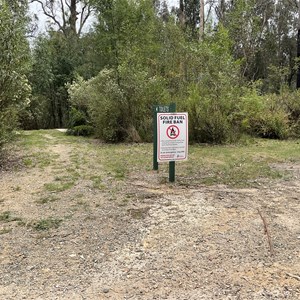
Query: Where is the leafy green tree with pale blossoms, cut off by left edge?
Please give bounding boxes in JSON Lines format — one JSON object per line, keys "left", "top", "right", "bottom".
{"left": 0, "top": 0, "right": 30, "bottom": 148}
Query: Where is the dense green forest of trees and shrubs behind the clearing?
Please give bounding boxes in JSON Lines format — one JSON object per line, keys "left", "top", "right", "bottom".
{"left": 0, "top": 0, "right": 300, "bottom": 149}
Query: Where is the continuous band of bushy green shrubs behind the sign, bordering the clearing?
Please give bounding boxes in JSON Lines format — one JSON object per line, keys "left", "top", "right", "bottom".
{"left": 69, "top": 26, "right": 300, "bottom": 144}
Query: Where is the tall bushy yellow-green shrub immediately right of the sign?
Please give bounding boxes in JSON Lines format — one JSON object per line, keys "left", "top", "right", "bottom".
{"left": 182, "top": 27, "right": 241, "bottom": 143}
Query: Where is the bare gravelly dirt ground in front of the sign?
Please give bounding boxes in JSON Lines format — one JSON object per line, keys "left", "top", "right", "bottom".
{"left": 0, "top": 135, "right": 300, "bottom": 300}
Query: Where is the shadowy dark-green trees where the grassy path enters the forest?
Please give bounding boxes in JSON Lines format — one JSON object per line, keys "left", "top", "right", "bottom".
{"left": 30, "top": 31, "right": 84, "bottom": 128}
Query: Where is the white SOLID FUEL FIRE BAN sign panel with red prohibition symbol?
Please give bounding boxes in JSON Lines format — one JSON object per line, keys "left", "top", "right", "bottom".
{"left": 157, "top": 113, "right": 188, "bottom": 162}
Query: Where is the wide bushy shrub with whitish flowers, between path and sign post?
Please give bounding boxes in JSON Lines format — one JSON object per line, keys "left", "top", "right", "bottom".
{"left": 69, "top": 68, "right": 168, "bottom": 142}
